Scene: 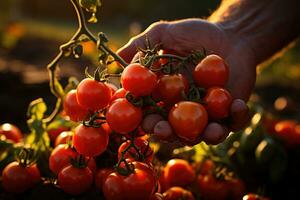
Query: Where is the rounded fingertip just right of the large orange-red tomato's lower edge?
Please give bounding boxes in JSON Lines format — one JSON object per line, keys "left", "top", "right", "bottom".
{"left": 202, "top": 122, "right": 229, "bottom": 145}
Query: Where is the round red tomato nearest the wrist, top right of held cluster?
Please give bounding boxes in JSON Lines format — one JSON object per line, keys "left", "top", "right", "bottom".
{"left": 193, "top": 55, "right": 229, "bottom": 88}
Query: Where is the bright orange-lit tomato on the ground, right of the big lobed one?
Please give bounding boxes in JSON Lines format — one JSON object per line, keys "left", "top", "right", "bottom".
{"left": 164, "top": 159, "right": 196, "bottom": 187}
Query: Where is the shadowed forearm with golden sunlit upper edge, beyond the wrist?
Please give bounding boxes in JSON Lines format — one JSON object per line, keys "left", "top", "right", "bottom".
{"left": 209, "top": 0, "right": 300, "bottom": 64}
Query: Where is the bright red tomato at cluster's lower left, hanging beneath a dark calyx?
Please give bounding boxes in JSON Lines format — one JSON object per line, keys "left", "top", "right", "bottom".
{"left": 73, "top": 124, "right": 109, "bottom": 157}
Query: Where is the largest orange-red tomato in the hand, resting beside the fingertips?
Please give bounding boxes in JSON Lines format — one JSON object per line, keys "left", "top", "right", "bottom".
{"left": 168, "top": 101, "right": 208, "bottom": 142}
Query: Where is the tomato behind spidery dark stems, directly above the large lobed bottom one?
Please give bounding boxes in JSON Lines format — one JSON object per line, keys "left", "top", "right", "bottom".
{"left": 118, "top": 137, "right": 154, "bottom": 163}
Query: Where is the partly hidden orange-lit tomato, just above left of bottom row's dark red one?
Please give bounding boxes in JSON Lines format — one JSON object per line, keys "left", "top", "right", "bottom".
{"left": 49, "top": 144, "right": 78, "bottom": 174}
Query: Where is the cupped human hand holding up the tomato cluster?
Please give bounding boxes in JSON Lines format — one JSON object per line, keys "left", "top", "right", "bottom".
{"left": 118, "top": 19, "right": 257, "bottom": 144}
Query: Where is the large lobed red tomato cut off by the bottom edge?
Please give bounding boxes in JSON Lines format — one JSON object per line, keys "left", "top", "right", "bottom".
{"left": 103, "top": 162, "right": 156, "bottom": 200}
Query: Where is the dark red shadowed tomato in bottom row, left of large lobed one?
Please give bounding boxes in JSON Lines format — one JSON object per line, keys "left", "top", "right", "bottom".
{"left": 58, "top": 165, "right": 93, "bottom": 195}
